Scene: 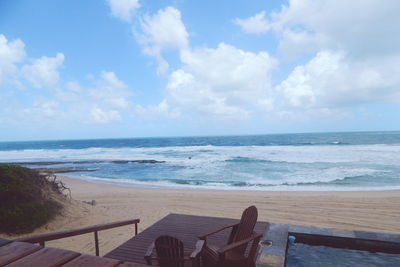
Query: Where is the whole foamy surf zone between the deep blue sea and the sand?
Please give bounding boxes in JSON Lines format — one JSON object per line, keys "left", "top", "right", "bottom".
{"left": 0, "top": 142, "right": 400, "bottom": 190}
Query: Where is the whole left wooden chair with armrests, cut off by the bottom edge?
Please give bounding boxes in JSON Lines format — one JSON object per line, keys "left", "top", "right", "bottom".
{"left": 144, "top": 235, "right": 205, "bottom": 267}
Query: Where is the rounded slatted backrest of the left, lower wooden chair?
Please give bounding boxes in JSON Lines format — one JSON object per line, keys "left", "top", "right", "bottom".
{"left": 154, "top": 235, "right": 184, "bottom": 267}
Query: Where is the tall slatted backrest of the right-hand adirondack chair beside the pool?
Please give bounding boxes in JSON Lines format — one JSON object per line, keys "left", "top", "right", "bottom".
{"left": 230, "top": 206, "right": 258, "bottom": 253}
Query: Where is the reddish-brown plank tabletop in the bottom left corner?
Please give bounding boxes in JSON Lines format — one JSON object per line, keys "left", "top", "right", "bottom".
{"left": 0, "top": 238, "right": 148, "bottom": 267}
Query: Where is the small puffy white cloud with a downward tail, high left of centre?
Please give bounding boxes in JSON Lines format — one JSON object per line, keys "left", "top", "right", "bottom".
{"left": 136, "top": 7, "right": 189, "bottom": 73}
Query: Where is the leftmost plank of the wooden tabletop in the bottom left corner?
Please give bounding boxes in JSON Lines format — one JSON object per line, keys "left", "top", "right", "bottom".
{"left": 0, "top": 242, "right": 42, "bottom": 266}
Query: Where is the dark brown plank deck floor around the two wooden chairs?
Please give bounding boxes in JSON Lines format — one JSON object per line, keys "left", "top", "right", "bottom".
{"left": 104, "top": 214, "right": 267, "bottom": 263}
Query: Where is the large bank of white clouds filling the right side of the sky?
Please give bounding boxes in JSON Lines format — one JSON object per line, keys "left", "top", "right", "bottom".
{"left": 258, "top": 0, "right": 400, "bottom": 113}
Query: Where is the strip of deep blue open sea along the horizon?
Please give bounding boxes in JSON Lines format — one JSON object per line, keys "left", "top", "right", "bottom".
{"left": 0, "top": 132, "right": 400, "bottom": 151}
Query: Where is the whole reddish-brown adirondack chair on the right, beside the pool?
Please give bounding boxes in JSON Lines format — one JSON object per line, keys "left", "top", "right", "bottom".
{"left": 199, "top": 206, "right": 262, "bottom": 267}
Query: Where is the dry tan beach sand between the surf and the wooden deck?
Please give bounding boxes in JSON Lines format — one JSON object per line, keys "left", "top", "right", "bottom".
{"left": 3, "top": 177, "right": 400, "bottom": 255}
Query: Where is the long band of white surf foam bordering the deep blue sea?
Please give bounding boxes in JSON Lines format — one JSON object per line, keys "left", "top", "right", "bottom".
{"left": 0, "top": 145, "right": 400, "bottom": 163}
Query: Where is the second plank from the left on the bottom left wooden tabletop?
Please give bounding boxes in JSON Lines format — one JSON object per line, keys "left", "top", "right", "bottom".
{"left": 7, "top": 247, "right": 81, "bottom": 267}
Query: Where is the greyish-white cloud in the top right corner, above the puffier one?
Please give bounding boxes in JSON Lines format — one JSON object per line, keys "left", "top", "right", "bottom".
{"left": 260, "top": 0, "right": 400, "bottom": 57}
